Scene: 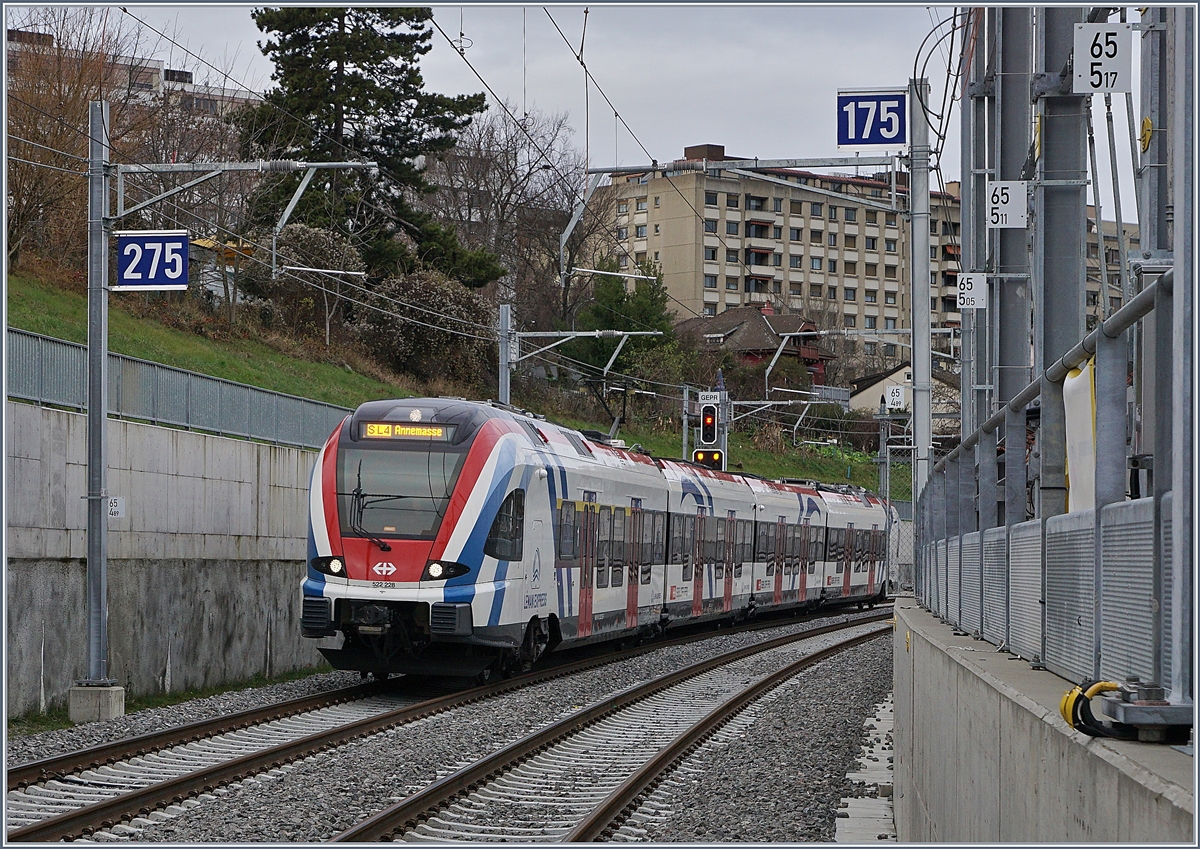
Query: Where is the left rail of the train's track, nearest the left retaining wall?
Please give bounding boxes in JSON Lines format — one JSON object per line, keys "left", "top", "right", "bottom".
{"left": 7, "top": 679, "right": 398, "bottom": 793}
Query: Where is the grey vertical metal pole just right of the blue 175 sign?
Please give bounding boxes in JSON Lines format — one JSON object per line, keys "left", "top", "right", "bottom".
{"left": 908, "top": 79, "right": 934, "bottom": 499}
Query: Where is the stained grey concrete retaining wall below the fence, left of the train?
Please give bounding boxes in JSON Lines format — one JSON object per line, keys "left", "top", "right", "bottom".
{"left": 5, "top": 402, "right": 340, "bottom": 716}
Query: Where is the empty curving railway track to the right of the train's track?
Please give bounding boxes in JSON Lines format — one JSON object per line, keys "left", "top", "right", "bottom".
{"left": 334, "top": 621, "right": 890, "bottom": 843}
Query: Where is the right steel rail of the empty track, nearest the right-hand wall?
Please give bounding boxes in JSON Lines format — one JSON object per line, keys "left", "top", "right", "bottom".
{"left": 562, "top": 627, "right": 890, "bottom": 843}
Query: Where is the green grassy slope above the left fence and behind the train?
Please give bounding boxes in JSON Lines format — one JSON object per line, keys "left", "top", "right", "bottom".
{"left": 7, "top": 275, "right": 878, "bottom": 489}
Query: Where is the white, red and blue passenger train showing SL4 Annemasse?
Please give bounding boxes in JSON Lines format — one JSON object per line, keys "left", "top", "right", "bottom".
{"left": 301, "top": 398, "right": 888, "bottom": 678}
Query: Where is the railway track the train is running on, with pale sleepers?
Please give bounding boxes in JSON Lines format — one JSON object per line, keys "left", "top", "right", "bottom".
{"left": 6, "top": 612, "right": 890, "bottom": 842}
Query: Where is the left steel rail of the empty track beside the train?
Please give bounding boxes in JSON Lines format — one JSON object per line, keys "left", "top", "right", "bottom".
{"left": 332, "top": 612, "right": 892, "bottom": 843}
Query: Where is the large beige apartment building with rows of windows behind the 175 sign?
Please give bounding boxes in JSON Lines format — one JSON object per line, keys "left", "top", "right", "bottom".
{"left": 606, "top": 145, "right": 961, "bottom": 357}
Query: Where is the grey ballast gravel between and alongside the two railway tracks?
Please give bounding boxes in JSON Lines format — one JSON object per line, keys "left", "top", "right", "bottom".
{"left": 10, "top": 615, "right": 892, "bottom": 843}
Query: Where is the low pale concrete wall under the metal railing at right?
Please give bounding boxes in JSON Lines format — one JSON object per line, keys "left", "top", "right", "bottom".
{"left": 893, "top": 598, "right": 1195, "bottom": 843}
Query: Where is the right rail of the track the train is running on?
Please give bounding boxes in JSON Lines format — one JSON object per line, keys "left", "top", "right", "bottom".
{"left": 6, "top": 609, "right": 892, "bottom": 843}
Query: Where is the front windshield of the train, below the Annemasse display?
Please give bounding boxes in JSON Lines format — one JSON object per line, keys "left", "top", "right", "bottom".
{"left": 337, "top": 446, "right": 467, "bottom": 540}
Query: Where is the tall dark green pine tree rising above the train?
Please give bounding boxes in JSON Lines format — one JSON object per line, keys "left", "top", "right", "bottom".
{"left": 241, "top": 7, "right": 504, "bottom": 285}
